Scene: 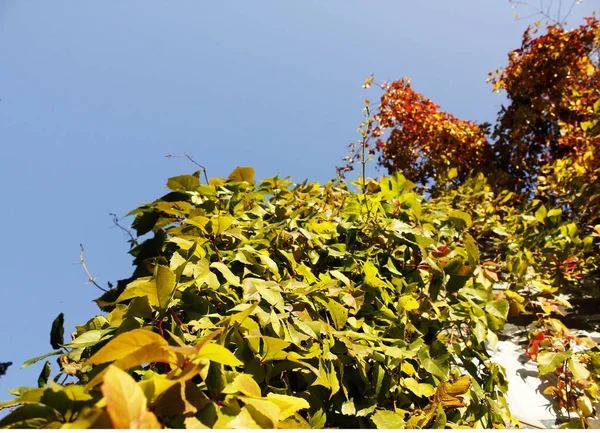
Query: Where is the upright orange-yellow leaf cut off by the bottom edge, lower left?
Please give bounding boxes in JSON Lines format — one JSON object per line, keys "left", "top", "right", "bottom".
{"left": 100, "top": 366, "right": 162, "bottom": 429}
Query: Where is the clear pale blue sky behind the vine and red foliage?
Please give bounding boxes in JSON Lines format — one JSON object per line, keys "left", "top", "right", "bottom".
{"left": 0, "top": 0, "right": 594, "bottom": 401}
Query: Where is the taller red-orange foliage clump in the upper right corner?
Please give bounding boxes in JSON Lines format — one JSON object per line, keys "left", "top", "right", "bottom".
{"left": 490, "top": 17, "right": 600, "bottom": 191}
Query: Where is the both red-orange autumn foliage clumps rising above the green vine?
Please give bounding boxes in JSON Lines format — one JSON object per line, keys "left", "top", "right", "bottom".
{"left": 343, "top": 17, "right": 600, "bottom": 196}
